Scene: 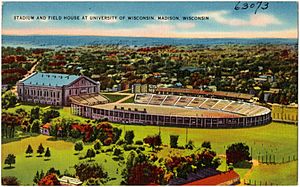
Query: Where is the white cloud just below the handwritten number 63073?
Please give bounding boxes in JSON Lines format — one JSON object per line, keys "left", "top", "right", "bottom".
{"left": 201, "top": 10, "right": 281, "bottom": 27}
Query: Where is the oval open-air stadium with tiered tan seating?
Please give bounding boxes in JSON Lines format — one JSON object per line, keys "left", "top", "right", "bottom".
{"left": 70, "top": 93, "right": 272, "bottom": 128}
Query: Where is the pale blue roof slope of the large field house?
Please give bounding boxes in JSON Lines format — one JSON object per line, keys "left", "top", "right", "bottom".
{"left": 21, "top": 73, "right": 80, "bottom": 87}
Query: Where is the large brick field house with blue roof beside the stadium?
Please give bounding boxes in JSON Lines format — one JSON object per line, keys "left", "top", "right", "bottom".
{"left": 17, "top": 72, "right": 100, "bottom": 106}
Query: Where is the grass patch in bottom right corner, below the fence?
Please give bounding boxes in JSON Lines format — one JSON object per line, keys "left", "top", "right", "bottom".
{"left": 249, "top": 161, "right": 298, "bottom": 185}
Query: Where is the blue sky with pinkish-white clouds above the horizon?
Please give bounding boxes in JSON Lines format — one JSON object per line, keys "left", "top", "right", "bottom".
{"left": 2, "top": 1, "right": 298, "bottom": 38}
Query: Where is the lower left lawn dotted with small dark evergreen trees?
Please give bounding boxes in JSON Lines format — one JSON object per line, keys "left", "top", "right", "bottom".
{"left": 1, "top": 135, "right": 128, "bottom": 185}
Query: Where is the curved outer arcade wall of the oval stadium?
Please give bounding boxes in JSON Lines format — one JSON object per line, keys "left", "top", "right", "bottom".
{"left": 71, "top": 103, "right": 272, "bottom": 128}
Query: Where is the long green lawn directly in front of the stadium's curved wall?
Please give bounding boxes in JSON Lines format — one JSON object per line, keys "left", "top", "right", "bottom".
{"left": 114, "top": 123, "right": 298, "bottom": 162}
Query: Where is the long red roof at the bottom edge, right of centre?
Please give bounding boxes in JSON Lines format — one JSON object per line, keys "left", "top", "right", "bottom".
{"left": 183, "top": 170, "right": 240, "bottom": 186}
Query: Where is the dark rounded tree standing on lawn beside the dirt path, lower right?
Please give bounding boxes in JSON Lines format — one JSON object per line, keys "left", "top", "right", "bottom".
{"left": 226, "top": 143, "right": 252, "bottom": 165}
